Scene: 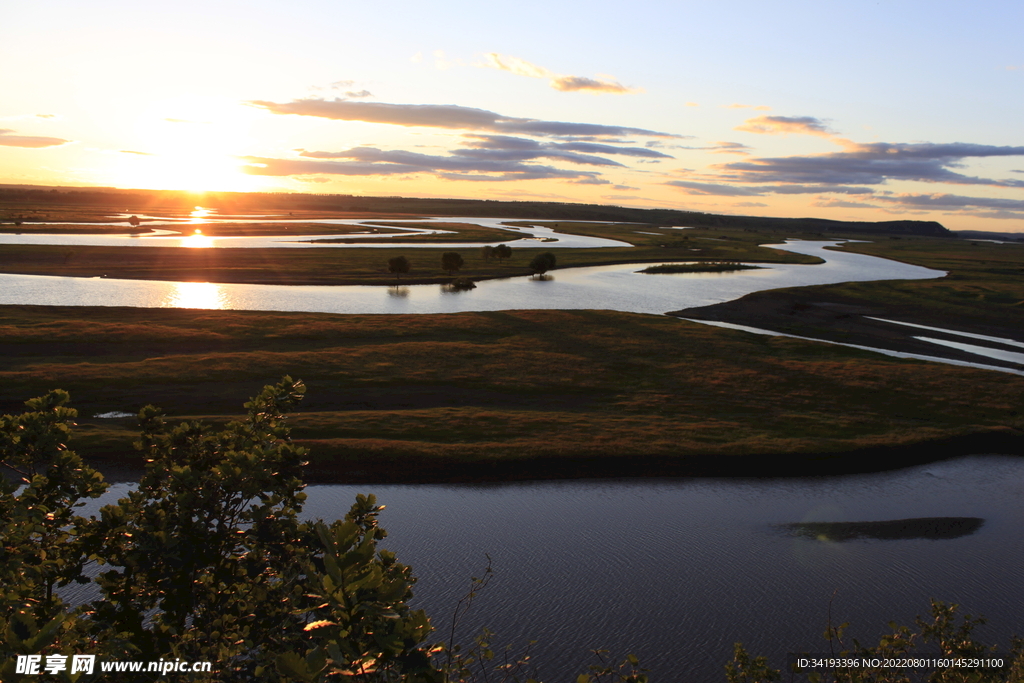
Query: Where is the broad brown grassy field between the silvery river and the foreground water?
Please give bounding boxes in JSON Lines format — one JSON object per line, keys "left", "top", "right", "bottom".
{"left": 0, "top": 306, "right": 1024, "bottom": 481}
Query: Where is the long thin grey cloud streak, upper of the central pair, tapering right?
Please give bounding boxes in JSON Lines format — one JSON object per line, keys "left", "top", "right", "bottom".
{"left": 247, "top": 98, "right": 678, "bottom": 137}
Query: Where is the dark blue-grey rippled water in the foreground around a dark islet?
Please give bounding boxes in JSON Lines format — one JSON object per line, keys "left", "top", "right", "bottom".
{"left": 81, "top": 456, "right": 1024, "bottom": 682}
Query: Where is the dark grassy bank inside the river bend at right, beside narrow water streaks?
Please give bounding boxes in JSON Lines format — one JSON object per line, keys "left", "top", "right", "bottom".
{"left": 673, "top": 239, "right": 1024, "bottom": 366}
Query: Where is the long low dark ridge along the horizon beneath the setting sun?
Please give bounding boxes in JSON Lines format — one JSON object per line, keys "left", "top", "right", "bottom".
{"left": 0, "top": 185, "right": 955, "bottom": 238}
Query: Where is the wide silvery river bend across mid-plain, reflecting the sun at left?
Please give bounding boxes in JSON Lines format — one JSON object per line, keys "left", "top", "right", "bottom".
{"left": 0, "top": 241, "right": 945, "bottom": 313}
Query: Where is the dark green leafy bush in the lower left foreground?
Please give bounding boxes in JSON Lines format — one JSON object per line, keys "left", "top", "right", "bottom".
{"left": 0, "top": 377, "right": 646, "bottom": 683}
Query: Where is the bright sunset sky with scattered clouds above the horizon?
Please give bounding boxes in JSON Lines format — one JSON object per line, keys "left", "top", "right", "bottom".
{"left": 0, "top": 0, "right": 1024, "bottom": 232}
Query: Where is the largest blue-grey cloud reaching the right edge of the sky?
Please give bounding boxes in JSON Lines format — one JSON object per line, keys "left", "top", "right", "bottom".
{"left": 715, "top": 140, "right": 1024, "bottom": 187}
